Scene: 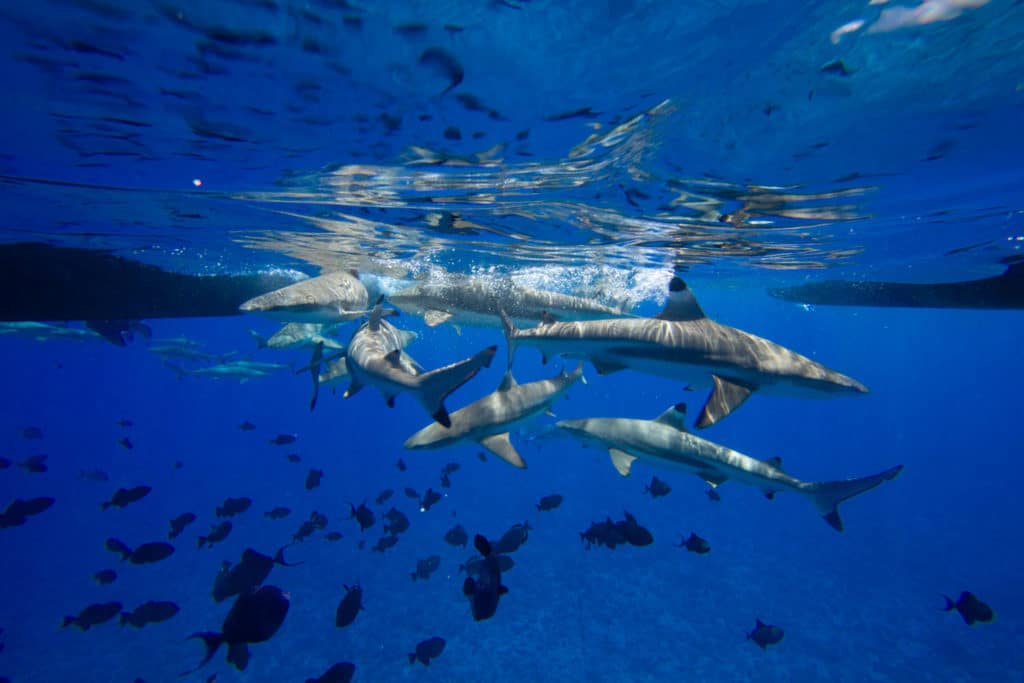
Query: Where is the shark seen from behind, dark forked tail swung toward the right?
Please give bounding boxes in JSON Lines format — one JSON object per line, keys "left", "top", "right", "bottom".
{"left": 344, "top": 303, "right": 498, "bottom": 427}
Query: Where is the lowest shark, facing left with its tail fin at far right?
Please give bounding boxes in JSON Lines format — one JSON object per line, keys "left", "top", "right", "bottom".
{"left": 557, "top": 403, "right": 903, "bottom": 531}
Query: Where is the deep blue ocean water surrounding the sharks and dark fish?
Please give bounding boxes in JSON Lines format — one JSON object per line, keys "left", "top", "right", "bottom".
{"left": 0, "top": 0, "right": 1024, "bottom": 682}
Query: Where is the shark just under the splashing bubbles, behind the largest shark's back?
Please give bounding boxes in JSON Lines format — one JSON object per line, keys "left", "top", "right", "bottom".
{"left": 388, "top": 276, "right": 628, "bottom": 330}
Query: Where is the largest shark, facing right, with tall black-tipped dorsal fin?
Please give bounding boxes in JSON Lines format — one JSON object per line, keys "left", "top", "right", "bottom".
{"left": 503, "top": 278, "right": 867, "bottom": 428}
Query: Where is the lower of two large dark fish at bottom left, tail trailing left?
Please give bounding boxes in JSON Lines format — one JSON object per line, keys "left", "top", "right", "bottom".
{"left": 182, "top": 586, "right": 290, "bottom": 676}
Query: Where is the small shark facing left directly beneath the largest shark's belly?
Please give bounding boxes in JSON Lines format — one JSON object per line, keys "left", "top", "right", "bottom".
{"left": 406, "top": 364, "right": 587, "bottom": 468}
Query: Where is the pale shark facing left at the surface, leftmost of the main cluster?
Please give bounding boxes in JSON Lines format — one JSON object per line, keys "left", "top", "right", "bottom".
{"left": 239, "top": 270, "right": 370, "bottom": 324}
